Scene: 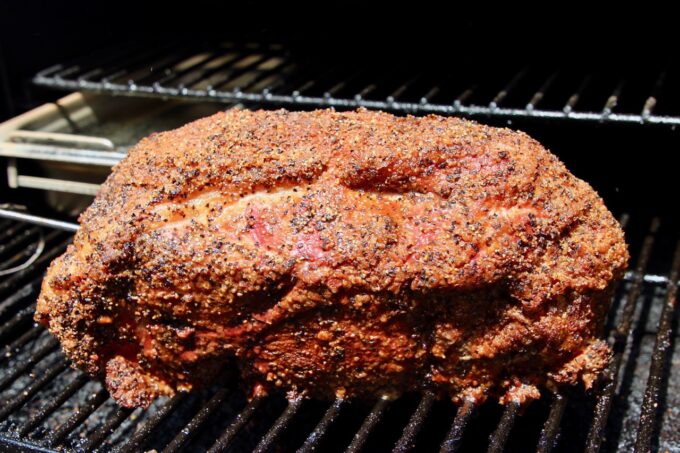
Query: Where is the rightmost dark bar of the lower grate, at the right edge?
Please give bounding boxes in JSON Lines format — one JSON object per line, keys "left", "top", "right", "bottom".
{"left": 635, "top": 238, "right": 680, "bottom": 452}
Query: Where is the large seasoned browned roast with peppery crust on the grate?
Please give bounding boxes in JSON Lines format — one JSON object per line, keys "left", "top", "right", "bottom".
{"left": 36, "top": 110, "right": 628, "bottom": 407}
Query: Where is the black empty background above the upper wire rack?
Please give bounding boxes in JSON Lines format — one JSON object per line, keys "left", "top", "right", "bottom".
{"left": 0, "top": 0, "right": 677, "bottom": 119}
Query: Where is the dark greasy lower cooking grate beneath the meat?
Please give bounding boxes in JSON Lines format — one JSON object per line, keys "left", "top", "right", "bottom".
{"left": 0, "top": 215, "right": 680, "bottom": 452}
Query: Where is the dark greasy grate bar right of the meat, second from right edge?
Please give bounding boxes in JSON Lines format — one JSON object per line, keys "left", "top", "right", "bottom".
{"left": 585, "top": 219, "right": 659, "bottom": 453}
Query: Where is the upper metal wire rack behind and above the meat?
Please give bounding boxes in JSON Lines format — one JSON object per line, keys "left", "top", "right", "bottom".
{"left": 33, "top": 44, "right": 680, "bottom": 127}
